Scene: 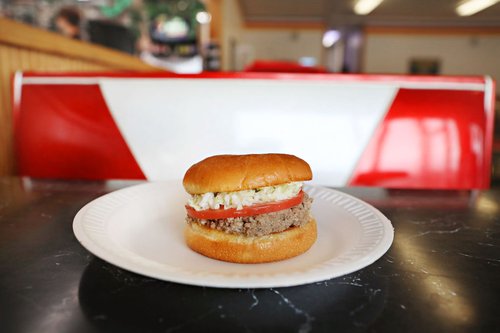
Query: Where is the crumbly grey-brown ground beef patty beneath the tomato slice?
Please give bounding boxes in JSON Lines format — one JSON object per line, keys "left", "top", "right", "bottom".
{"left": 186, "top": 193, "right": 312, "bottom": 236}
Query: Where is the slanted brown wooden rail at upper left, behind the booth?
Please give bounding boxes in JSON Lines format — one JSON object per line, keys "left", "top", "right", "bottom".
{"left": 0, "top": 18, "right": 158, "bottom": 71}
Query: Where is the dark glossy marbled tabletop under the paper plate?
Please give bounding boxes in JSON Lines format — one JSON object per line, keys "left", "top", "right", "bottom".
{"left": 0, "top": 177, "right": 500, "bottom": 332}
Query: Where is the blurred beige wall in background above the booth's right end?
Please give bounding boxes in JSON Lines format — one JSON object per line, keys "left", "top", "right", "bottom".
{"left": 362, "top": 33, "right": 500, "bottom": 92}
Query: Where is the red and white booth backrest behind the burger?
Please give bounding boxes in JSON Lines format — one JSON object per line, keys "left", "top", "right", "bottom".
{"left": 14, "top": 73, "right": 494, "bottom": 189}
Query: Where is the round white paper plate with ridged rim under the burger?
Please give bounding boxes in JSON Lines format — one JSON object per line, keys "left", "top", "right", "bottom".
{"left": 73, "top": 181, "right": 394, "bottom": 288}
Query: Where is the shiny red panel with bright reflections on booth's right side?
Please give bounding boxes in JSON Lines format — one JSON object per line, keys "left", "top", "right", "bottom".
{"left": 349, "top": 89, "right": 491, "bottom": 189}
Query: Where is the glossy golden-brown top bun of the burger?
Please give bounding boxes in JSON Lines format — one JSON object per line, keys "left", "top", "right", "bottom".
{"left": 182, "top": 154, "right": 312, "bottom": 194}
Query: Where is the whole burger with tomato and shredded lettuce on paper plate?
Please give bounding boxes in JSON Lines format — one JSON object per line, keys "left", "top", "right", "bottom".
{"left": 183, "top": 154, "right": 317, "bottom": 263}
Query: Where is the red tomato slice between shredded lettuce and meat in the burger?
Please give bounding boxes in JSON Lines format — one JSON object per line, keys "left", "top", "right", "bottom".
{"left": 186, "top": 191, "right": 304, "bottom": 220}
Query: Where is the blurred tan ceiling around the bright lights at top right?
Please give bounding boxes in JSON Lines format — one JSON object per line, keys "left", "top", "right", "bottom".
{"left": 240, "top": 0, "right": 500, "bottom": 27}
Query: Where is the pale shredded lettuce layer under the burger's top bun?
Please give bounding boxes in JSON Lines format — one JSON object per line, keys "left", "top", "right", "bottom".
{"left": 188, "top": 182, "right": 302, "bottom": 211}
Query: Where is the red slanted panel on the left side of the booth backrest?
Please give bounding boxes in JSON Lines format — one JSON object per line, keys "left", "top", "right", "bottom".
{"left": 15, "top": 85, "right": 145, "bottom": 179}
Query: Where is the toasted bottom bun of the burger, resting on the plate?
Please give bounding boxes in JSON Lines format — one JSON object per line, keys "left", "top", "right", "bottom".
{"left": 184, "top": 219, "right": 317, "bottom": 264}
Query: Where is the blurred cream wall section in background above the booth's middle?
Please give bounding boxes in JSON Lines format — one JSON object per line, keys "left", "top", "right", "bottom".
{"left": 222, "top": 0, "right": 323, "bottom": 70}
